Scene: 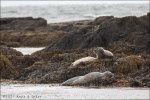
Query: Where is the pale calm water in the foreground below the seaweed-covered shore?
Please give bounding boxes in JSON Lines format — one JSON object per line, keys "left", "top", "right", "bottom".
{"left": 1, "top": 83, "right": 149, "bottom": 100}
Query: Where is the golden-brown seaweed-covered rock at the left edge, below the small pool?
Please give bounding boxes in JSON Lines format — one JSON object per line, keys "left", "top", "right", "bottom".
{"left": 0, "top": 53, "right": 18, "bottom": 78}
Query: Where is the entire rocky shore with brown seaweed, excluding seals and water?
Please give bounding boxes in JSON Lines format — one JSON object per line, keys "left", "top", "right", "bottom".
{"left": 0, "top": 13, "right": 150, "bottom": 87}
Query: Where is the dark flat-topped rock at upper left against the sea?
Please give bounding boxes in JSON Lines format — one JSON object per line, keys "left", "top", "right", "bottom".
{"left": 0, "top": 17, "right": 47, "bottom": 32}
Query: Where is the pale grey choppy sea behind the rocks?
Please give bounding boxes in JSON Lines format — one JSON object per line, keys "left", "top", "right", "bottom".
{"left": 1, "top": 2, "right": 149, "bottom": 23}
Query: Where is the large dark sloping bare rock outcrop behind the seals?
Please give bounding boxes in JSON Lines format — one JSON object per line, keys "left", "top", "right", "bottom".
{"left": 44, "top": 15, "right": 149, "bottom": 53}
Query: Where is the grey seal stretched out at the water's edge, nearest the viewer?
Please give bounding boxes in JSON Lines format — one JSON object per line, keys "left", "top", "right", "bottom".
{"left": 61, "top": 71, "right": 114, "bottom": 86}
